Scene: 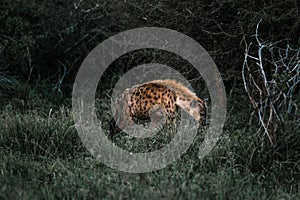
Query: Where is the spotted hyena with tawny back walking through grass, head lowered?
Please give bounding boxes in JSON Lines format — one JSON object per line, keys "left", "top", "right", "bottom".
{"left": 110, "top": 79, "right": 206, "bottom": 137}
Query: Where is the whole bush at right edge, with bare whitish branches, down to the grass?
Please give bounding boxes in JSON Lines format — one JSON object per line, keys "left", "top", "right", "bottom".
{"left": 242, "top": 19, "right": 300, "bottom": 162}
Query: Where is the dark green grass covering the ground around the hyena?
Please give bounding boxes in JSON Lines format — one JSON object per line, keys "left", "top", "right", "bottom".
{"left": 0, "top": 98, "right": 300, "bottom": 199}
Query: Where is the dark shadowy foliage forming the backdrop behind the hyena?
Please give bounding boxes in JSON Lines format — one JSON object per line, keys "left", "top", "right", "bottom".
{"left": 0, "top": 0, "right": 300, "bottom": 95}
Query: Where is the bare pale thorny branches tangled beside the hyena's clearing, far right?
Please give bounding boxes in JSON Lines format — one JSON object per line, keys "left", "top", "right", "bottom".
{"left": 242, "top": 20, "right": 300, "bottom": 150}
